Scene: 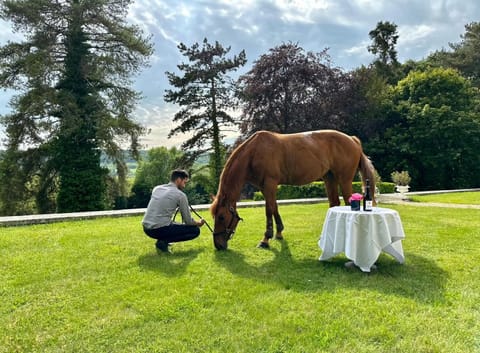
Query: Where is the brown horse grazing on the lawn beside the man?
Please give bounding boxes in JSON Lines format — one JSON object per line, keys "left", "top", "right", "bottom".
{"left": 210, "top": 130, "right": 375, "bottom": 250}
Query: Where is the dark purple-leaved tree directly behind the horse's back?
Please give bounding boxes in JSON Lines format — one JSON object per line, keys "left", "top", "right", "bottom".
{"left": 238, "top": 43, "right": 349, "bottom": 135}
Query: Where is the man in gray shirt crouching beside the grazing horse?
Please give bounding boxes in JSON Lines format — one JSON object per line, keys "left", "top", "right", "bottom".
{"left": 142, "top": 169, "right": 205, "bottom": 252}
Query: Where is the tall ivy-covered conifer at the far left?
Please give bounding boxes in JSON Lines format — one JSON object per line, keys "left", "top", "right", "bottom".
{"left": 0, "top": 0, "right": 152, "bottom": 212}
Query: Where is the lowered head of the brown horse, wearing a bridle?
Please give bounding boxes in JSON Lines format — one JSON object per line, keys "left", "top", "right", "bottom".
{"left": 211, "top": 198, "right": 242, "bottom": 250}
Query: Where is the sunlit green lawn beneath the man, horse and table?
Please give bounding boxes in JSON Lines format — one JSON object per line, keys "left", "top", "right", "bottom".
{"left": 0, "top": 204, "right": 480, "bottom": 353}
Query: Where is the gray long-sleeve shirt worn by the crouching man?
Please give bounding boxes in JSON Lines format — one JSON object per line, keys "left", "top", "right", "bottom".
{"left": 142, "top": 182, "right": 196, "bottom": 229}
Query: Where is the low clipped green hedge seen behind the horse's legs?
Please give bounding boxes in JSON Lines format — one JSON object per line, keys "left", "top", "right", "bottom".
{"left": 253, "top": 181, "right": 395, "bottom": 201}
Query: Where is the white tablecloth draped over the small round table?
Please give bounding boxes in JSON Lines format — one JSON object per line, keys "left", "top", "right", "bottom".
{"left": 318, "top": 206, "right": 405, "bottom": 272}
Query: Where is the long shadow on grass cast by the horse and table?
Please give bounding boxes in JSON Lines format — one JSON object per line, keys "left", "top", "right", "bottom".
{"left": 215, "top": 240, "right": 448, "bottom": 303}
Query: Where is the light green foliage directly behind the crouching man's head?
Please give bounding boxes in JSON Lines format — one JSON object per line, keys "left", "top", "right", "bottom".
{"left": 128, "top": 147, "right": 186, "bottom": 208}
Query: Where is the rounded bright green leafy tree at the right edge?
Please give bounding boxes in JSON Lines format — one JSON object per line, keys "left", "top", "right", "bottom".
{"left": 366, "top": 68, "right": 480, "bottom": 190}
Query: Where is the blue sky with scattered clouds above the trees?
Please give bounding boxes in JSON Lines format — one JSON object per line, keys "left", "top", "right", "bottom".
{"left": 0, "top": 0, "right": 480, "bottom": 148}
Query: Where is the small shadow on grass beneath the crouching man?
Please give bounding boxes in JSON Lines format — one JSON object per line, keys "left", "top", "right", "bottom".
{"left": 138, "top": 249, "right": 203, "bottom": 277}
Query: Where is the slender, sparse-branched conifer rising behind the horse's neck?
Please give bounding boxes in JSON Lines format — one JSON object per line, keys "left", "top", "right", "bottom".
{"left": 165, "top": 38, "right": 247, "bottom": 189}
